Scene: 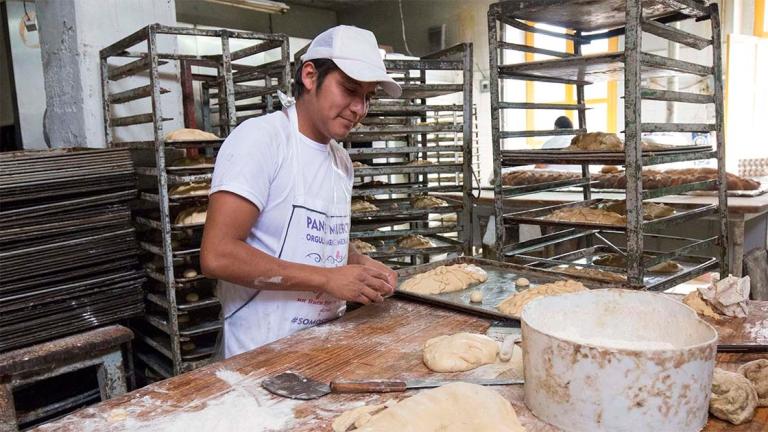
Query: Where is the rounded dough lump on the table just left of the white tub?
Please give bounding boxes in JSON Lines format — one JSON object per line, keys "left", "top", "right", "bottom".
{"left": 423, "top": 333, "right": 499, "bottom": 372}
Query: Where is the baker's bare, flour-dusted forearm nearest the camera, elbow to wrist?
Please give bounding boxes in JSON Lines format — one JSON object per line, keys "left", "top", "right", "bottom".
{"left": 200, "top": 240, "right": 326, "bottom": 291}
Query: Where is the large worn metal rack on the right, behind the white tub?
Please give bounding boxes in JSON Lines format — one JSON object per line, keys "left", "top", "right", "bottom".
{"left": 488, "top": 0, "right": 728, "bottom": 290}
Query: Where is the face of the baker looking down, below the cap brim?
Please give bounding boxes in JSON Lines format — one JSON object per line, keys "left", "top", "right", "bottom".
{"left": 305, "top": 63, "right": 376, "bottom": 141}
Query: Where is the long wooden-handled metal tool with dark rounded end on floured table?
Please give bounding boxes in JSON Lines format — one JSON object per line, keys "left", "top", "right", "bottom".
{"left": 261, "top": 372, "right": 523, "bottom": 400}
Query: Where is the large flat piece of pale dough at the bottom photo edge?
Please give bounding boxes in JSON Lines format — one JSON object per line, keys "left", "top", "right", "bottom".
{"left": 357, "top": 382, "right": 525, "bottom": 432}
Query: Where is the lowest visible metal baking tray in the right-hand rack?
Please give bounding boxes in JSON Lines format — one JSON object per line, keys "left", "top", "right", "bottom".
{"left": 515, "top": 245, "right": 719, "bottom": 291}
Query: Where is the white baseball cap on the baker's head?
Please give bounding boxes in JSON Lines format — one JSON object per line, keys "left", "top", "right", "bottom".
{"left": 301, "top": 26, "right": 403, "bottom": 97}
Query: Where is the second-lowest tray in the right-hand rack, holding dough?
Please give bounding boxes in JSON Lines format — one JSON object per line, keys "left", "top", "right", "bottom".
{"left": 504, "top": 198, "right": 717, "bottom": 231}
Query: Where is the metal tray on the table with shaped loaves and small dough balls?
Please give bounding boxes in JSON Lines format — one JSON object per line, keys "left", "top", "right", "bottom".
{"left": 395, "top": 257, "right": 616, "bottom": 321}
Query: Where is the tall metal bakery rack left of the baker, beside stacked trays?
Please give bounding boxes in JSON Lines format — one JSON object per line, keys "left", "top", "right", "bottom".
{"left": 100, "top": 24, "right": 290, "bottom": 381}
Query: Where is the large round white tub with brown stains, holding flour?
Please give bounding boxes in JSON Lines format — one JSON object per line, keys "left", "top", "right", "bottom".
{"left": 522, "top": 289, "right": 717, "bottom": 432}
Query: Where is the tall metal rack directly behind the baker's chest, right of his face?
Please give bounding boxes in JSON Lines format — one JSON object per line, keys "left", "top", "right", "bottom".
{"left": 344, "top": 43, "right": 473, "bottom": 267}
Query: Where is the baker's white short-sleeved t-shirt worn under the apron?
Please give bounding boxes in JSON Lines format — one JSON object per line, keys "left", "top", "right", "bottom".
{"left": 210, "top": 111, "right": 353, "bottom": 350}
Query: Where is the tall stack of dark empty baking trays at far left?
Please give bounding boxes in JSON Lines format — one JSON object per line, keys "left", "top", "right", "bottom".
{"left": 0, "top": 149, "right": 144, "bottom": 352}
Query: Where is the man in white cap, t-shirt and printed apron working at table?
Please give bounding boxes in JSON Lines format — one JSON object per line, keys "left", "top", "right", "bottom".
{"left": 200, "top": 26, "right": 401, "bottom": 357}
